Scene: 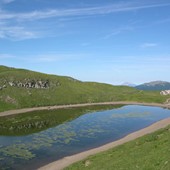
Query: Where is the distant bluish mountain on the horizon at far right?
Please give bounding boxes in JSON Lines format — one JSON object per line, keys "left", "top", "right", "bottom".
{"left": 135, "top": 81, "right": 170, "bottom": 90}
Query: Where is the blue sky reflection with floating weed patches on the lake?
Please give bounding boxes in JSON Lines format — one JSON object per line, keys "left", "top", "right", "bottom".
{"left": 0, "top": 105, "right": 170, "bottom": 169}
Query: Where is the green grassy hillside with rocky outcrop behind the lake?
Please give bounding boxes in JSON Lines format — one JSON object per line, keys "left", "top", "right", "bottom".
{"left": 0, "top": 66, "right": 167, "bottom": 111}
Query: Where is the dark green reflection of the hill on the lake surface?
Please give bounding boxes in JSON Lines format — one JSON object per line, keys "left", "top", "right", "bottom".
{"left": 0, "top": 105, "right": 122, "bottom": 136}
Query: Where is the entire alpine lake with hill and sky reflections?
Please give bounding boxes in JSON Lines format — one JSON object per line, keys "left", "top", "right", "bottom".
{"left": 0, "top": 105, "right": 170, "bottom": 170}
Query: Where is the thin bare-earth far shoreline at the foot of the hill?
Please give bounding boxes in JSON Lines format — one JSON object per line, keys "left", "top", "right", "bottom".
{"left": 0, "top": 101, "right": 170, "bottom": 117}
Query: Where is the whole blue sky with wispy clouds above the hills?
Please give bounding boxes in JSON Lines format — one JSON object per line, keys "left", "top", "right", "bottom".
{"left": 0, "top": 0, "right": 170, "bottom": 84}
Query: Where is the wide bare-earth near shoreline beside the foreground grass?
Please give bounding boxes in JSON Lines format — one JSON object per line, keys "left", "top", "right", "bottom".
{"left": 38, "top": 118, "right": 170, "bottom": 170}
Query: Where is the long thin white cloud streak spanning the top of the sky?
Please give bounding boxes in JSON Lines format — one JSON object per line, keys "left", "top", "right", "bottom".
{"left": 0, "top": 0, "right": 170, "bottom": 20}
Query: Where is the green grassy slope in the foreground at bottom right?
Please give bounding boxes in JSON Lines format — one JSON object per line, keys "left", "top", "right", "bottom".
{"left": 66, "top": 126, "right": 170, "bottom": 170}
